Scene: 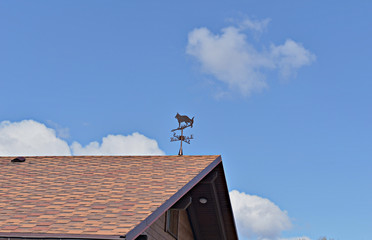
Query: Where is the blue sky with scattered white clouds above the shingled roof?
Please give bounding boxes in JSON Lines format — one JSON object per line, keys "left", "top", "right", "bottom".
{"left": 0, "top": 0, "right": 372, "bottom": 240}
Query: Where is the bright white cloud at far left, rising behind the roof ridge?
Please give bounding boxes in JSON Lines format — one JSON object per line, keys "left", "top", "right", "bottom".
{"left": 0, "top": 120, "right": 71, "bottom": 156}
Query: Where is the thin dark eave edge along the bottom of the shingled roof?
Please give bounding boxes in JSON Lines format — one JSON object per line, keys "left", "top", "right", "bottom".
{"left": 0, "top": 232, "right": 122, "bottom": 240}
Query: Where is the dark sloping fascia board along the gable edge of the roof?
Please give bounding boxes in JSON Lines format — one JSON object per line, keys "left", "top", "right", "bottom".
{"left": 123, "top": 156, "right": 222, "bottom": 240}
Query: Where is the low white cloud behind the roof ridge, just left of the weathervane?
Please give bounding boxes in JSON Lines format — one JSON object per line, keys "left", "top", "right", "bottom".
{"left": 71, "top": 132, "right": 164, "bottom": 155}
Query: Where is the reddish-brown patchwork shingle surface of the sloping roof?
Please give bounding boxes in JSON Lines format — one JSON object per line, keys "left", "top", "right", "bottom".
{"left": 0, "top": 156, "right": 218, "bottom": 235}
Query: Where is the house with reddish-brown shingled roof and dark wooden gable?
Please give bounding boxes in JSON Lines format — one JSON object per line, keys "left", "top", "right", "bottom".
{"left": 0, "top": 155, "right": 238, "bottom": 240}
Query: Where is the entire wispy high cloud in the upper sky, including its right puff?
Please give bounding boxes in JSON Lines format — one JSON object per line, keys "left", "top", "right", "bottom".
{"left": 186, "top": 19, "right": 315, "bottom": 95}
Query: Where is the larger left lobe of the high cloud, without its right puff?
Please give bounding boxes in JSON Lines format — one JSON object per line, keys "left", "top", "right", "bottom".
{"left": 187, "top": 27, "right": 274, "bottom": 94}
